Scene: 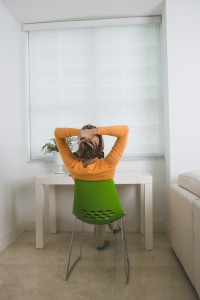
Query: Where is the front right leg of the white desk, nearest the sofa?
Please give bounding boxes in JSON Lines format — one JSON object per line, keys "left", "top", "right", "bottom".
{"left": 144, "top": 183, "right": 153, "bottom": 250}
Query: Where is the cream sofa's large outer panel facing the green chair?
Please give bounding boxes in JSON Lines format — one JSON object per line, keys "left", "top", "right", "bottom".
{"left": 170, "top": 183, "right": 196, "bottom": 284}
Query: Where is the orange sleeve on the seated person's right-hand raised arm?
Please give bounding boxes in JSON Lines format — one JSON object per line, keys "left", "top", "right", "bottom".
{"left": 98, "top": 125, "right": 129, "bottom": 167}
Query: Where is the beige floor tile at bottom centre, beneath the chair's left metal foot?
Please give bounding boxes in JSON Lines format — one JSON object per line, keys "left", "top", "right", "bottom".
{"left": 31, "top": 264, "right": 115, "bottom": 300}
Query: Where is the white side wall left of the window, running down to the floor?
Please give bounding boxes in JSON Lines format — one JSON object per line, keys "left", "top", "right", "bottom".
{"left": 0, "top": 3, "right": 24, "bottom": 251}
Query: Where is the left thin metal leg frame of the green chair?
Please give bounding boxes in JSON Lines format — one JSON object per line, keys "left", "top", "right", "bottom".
{"left": 65, "top": 218, "right": 84, "bottom": 280}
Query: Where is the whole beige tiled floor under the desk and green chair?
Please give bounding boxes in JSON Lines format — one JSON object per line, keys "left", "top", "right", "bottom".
{"left": 0, "top": 233, "right": 199, "bottom": 300}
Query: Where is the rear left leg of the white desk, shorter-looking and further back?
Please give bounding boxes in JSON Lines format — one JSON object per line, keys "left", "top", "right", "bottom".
{"left": 49, "top": 185, "right": 57, "bottom": 233}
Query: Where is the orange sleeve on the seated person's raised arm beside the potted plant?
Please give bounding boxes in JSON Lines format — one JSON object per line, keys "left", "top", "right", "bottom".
{"left": 54, "top": 128, "right": 80, "bottom": 167}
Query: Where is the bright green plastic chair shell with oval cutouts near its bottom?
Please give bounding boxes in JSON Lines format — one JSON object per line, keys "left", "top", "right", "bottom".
{"left": 73, "top": 179, "right": 126, "bottom": 224}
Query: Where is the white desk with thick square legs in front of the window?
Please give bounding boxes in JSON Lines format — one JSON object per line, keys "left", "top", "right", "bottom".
{"left": 35, "top": 172, "right": 153, "bottom": 250}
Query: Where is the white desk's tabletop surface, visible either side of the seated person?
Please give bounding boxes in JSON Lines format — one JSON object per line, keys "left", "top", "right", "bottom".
{"left": 35, "top": 171, "right": 152, "bottom": 185}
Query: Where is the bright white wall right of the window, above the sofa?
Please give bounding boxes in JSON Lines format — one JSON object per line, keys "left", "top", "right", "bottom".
{"left": 166, "top": 0, "right": 200, "bottom": 181}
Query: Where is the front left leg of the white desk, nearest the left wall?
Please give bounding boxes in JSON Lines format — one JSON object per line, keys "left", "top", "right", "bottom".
{"left": 35, "top": 184, "right": 44, "bottom": 248}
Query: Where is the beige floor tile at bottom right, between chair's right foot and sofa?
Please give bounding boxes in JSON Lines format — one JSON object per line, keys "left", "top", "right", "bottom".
{"left": 115, "top": 266, "right": 199, "bottom": 300}
